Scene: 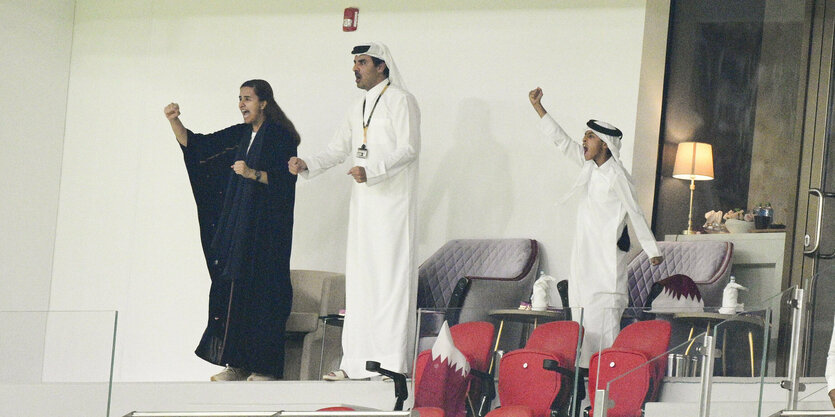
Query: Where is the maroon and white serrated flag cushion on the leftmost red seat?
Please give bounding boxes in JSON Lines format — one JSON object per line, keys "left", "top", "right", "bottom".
{"left": 415, "top": 322, "right": 470, "bottom": 417}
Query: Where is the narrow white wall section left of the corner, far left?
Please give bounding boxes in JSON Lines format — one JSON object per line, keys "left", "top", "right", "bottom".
{"left": 0, "top": 0, "right": 74, "bottom": 383}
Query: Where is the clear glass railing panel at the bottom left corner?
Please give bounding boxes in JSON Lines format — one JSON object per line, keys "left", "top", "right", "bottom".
{"left": 0, "top": 311, "right": 117, "bottom": 417}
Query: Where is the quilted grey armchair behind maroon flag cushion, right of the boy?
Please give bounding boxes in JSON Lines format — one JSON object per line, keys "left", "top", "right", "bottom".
{"left": 627, "top": 241, "right": 734, "bottom": 307}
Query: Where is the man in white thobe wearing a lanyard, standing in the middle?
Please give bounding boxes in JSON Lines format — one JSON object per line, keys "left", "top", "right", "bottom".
{"left": 288, "top": 42, "right": 420, "bottom": 380}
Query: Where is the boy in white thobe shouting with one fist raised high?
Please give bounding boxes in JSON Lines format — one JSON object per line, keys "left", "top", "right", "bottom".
{"left": 529, "top": 88, "right": 663, "bottom": 372}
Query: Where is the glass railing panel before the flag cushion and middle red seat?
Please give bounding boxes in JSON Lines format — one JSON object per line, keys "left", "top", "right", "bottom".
{"left": 410, "top": 302, "right": 583, "bottom": 415}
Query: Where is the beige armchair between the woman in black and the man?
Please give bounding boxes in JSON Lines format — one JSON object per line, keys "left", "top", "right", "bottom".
{"left": 284, "top": 269, "right": 345, "bottom": 380}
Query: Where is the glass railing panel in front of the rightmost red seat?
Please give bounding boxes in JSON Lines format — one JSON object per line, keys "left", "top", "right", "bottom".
{"left": 592, "top": 306, "right": 771, "bottom": 415}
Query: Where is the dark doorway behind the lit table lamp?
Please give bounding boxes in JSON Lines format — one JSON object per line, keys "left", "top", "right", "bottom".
{"left": 653, "top": 0, "right": 824, "bottom": 376}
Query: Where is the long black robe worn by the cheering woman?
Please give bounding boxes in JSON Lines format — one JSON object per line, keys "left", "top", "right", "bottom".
{"left": 182, "top": 122, "right": 296, "bottom": 378}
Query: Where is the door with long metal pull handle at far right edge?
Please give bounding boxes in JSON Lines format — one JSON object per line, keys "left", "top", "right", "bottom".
{"left": 787, "top": 0, "right": 835, "bottom": 376}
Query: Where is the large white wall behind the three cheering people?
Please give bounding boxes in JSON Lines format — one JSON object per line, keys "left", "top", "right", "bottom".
{"left": 50, "top": 0, "right": 654, "bottom": 381}
